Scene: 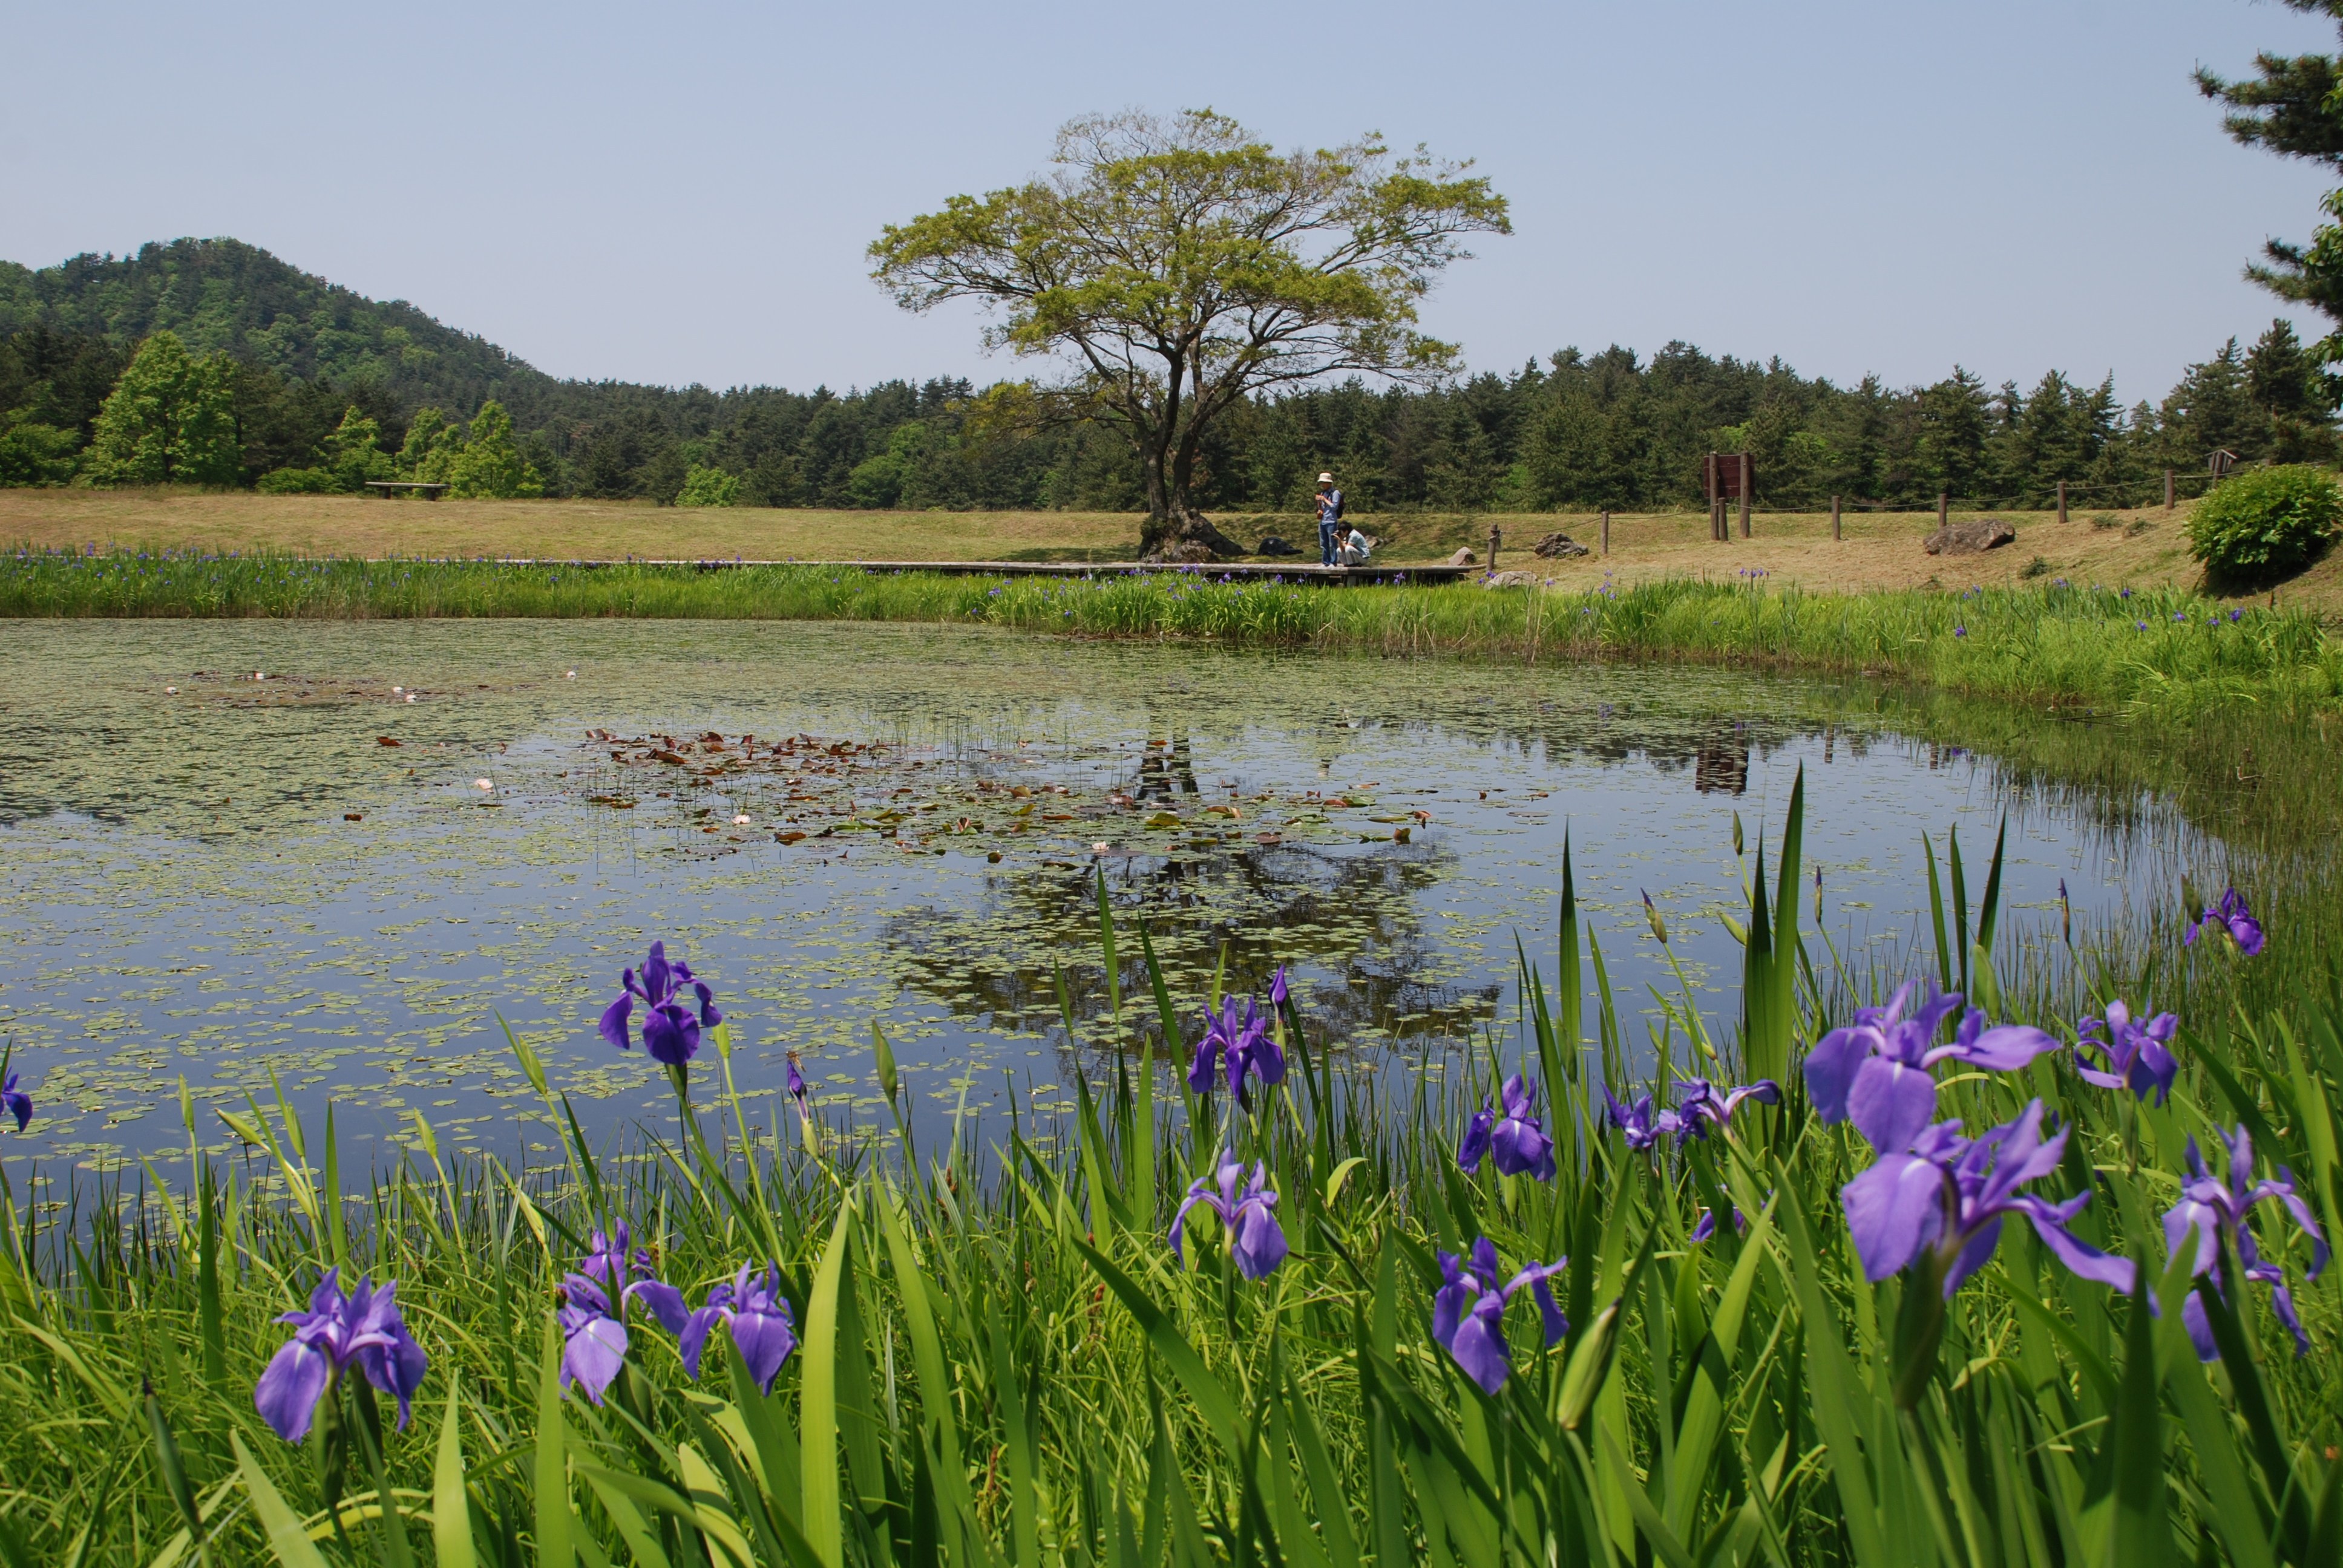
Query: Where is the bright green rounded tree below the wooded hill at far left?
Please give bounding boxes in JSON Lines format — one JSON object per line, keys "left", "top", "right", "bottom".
{"left": 82, "top": 333, "right": 244, "bottom": 485}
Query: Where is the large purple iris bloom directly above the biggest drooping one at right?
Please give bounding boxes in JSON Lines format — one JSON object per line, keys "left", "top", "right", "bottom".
{"left": 1806, "top": 980, "right": 2059, "bottom": 1153}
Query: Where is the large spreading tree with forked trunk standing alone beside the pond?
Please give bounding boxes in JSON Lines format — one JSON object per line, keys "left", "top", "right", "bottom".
{"left": 870, "top": 110, "right": 1511, "bottom": 560}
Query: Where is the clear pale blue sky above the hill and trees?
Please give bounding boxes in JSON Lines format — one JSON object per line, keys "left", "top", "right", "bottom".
{"left": 0, "top": 0, "right": 2336, "bottom": 401}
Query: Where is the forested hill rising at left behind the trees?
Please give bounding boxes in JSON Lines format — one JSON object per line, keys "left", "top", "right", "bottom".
{"left": 0, "top": 239, "right": 555, "bottom": 413}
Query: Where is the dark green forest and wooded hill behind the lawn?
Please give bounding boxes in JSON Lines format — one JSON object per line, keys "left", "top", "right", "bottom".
{"left": 0, "top": 241, "right": 2338, "bottom": 514}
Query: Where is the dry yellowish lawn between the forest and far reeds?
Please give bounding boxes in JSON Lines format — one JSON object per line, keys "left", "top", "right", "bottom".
{"left": 0, "top": 490, "right": 2343, "bottom": 614}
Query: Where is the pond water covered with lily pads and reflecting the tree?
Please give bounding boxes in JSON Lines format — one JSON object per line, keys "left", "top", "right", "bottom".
{"left": 0, "top": 621, "right": 2221, "bottom": 1167}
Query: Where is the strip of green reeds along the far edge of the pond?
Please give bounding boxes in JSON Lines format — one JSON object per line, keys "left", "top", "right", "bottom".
{"left": 0, "top": 550, "right": 2343, "bottom": 717}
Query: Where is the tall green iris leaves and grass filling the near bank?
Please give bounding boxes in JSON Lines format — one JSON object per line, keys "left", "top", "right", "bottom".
{"left": 0, "top": 806, "right": 2343, "bottom": 1568}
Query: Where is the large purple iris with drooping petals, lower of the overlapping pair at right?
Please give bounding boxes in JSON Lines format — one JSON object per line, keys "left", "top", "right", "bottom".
{"left": 1840, "top": 1099, "right": 2134, "bottom": 1301}
